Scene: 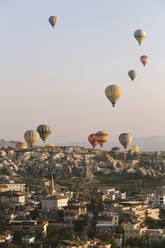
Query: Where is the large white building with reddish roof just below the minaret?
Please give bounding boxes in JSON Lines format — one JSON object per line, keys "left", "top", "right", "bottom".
{"left": 42, "top": 195, "right": 69, "bottom": 210}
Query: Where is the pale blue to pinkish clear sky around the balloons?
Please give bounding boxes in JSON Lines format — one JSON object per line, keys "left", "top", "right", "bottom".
{"left": 0, "top": 0, "right": 165, "bottom": 143}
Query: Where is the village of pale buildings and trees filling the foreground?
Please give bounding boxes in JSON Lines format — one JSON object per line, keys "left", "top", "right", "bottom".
{"left": 0, "top": 177, "right": 165, "bottom": 248}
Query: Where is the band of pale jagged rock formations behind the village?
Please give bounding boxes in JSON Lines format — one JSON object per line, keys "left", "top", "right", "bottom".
{"left": 0, "top": 147, "right": 165, "bottom": 179}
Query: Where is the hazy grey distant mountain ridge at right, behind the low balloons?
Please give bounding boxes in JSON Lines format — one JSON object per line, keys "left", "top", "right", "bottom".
{"left": 59, "top": 136, "right": 165, "bottom": 151}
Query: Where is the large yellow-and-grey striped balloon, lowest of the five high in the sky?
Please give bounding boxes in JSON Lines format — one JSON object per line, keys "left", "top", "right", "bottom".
{"left": 105, "top": 85, "right": 122, "bottom": 107}
